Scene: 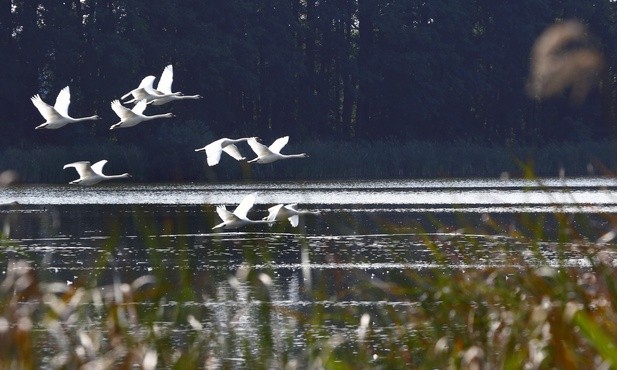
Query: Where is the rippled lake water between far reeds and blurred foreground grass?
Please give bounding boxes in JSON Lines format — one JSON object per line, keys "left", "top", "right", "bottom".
{"left": 0, "top": 178, "right": 617, "bottom": 361}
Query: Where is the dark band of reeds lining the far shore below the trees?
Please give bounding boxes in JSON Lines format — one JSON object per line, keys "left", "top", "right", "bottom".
{"left": 0, "top": 131, "right": 617, "bottom": 184}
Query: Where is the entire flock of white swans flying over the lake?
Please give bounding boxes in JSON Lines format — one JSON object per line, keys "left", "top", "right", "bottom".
{"left": 31, "top": 64, "right": 319, "bottom": 229}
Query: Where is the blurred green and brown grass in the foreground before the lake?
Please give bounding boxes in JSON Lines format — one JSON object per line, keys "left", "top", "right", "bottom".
{"left": 0, "top": 205, "right": 617, "bottom": 369}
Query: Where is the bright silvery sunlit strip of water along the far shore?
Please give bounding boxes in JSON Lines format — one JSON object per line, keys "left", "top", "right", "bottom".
{"left": 0, "top": 178, "right": 617, "bottom": 211}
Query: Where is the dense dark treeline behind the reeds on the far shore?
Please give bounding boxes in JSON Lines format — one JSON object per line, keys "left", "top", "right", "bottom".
{"left": 0, "top": 0, "right": 617, "bottom": 181}
